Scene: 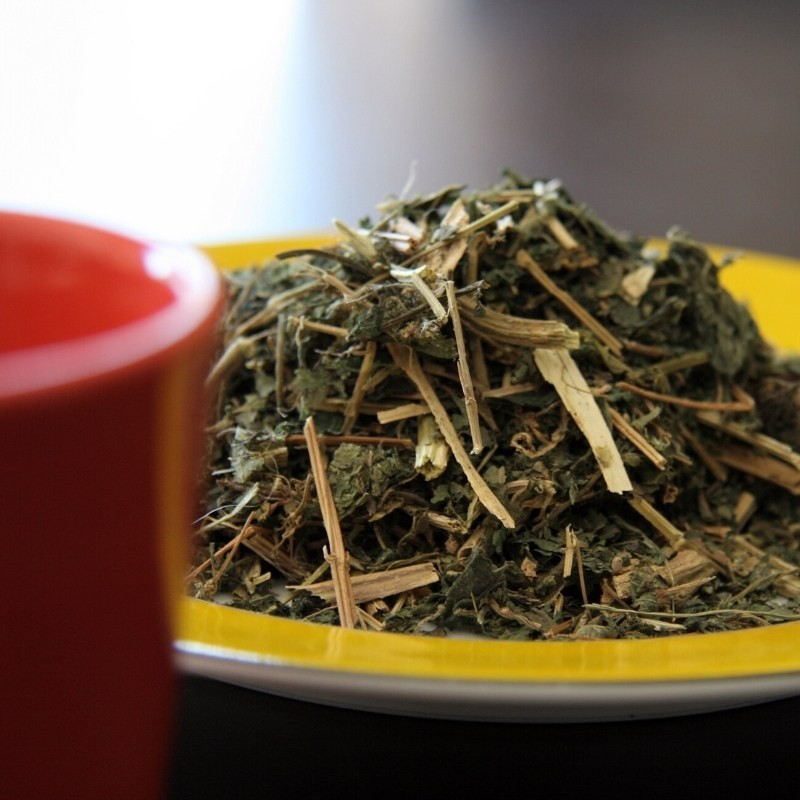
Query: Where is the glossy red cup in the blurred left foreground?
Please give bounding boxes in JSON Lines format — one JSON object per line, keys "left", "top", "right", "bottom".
{"left": 0, "top": 213, "right": 221, "bottom": 800}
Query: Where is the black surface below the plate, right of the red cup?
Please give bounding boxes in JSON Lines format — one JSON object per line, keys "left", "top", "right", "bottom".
{"left": 165, "top": 678, "right": 800, "bottom": 800}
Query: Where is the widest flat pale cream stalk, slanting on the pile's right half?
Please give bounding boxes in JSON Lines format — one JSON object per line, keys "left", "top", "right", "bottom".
{"left": 533, "top": 348, "right": 633, "bottom": 494}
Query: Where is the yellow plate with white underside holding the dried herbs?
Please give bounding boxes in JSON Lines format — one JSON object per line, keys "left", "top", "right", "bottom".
{"left": 175, "top": 236, "right": 800, "bottom": 722}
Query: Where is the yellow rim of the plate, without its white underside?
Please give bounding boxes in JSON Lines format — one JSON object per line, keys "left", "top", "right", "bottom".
{"left": 181, "top": 233, "right": 800, "bottom": 684}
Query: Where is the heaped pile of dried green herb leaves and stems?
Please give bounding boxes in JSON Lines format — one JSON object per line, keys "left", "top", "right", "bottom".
{"left": 189, "top": 173, "right": 800, "bottom": 639}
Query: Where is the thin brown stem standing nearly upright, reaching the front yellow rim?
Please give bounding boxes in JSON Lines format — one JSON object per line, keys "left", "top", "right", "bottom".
{"left": 303, "top": 417, "right": 357, "bottom": 628}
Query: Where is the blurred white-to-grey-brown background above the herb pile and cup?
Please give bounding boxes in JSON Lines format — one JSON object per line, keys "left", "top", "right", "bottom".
{"left": 0, "top": 0, "right": 800, "bottom": 256}
